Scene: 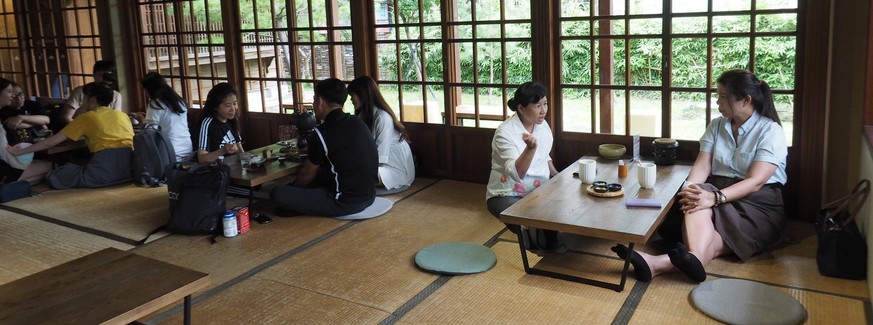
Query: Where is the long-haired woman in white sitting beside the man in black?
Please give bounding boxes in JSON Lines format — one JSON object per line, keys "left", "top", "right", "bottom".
{"left": 348, "top": 76, "right": 415, "bottom": 194}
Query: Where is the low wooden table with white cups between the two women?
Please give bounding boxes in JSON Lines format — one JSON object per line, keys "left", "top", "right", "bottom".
{"left": 500, "top": 157, "right": 691, "bottom": 291}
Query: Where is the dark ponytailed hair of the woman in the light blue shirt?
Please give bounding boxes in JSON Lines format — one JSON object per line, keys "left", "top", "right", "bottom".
{"left": 716, "top": 69, "right": 782, "bottom": 125}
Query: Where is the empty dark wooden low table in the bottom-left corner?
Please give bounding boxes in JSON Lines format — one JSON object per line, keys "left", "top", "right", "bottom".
{"left": 0, "top": 248, "right": 210, "bottom": 324}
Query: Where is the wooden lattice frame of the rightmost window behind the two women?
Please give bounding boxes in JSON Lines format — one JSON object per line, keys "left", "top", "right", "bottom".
{"left": 556, "top": 0, "right": 800, "bottom": 138}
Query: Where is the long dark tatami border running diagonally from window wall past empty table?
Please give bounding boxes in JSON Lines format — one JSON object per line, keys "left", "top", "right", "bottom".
{"left": 146, "top": 180, "right": 446, "bottom": 324}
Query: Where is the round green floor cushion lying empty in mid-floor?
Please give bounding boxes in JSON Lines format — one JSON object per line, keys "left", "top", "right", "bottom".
{"left": 415, "top": 242, "right": 497, "bottom": 274}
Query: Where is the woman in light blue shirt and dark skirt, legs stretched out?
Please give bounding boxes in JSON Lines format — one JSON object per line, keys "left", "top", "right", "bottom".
{"left": 612, "top": 70, "right": 788, "bottom": 282}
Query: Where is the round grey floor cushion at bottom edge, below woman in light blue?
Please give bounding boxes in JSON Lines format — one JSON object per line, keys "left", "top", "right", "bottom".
{"left": 691, "top": 279, "right": 806, "bottom": 324}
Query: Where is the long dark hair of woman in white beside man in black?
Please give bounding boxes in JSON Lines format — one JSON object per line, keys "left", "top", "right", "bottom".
{"left": 348, "top": 76, "right": 409, "bottom": 142}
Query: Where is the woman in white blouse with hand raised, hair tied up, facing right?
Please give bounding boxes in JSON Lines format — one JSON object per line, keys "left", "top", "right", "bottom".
{"left": 486, "top": 82, "right": 559, "bottom": 250}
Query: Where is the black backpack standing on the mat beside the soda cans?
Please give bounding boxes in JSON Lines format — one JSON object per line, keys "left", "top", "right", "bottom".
{"left": 139, "top": 162, "right": 230, "bottom": 245}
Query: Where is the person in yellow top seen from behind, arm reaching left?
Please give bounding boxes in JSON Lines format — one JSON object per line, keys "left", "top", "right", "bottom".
{"left": 6, "top": 82, "right": 133, "bottom": 189}
